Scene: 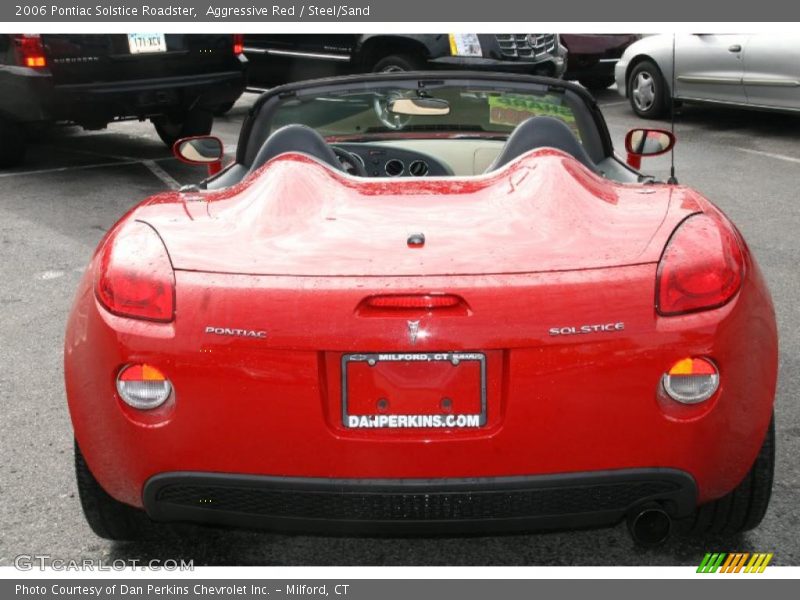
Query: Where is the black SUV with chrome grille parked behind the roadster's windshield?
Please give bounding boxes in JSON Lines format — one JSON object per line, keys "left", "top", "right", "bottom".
{"left": 244, "top": 33, "right": 566, "bottom": 85}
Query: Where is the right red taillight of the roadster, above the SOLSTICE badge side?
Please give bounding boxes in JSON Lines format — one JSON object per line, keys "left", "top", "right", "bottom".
{"left": 656, "top": 214, "right": 744, "bottom": 315}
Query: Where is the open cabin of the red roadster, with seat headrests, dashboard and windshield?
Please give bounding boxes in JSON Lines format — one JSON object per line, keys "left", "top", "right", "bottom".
{"left": 206, "top": 82, "right": 641, "bottom": 189}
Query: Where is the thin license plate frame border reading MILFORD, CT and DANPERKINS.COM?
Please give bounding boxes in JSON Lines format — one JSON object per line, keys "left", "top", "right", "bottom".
{"left": 340, "top": 352, "right": 487, "bottom": 430}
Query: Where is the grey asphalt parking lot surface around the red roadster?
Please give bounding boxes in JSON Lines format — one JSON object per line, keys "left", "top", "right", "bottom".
{"left": 0, "top": 90, "right": 800, "bottom": 565}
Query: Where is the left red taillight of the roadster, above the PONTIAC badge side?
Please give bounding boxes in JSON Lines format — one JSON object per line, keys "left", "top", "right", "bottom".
{"left": 94, "top": 221, "right": 175, "bottom": 322}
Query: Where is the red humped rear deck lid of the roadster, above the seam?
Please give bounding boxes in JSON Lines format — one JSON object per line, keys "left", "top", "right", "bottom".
{"left": 139, "top": 150, "right": 697, "bottom": 276}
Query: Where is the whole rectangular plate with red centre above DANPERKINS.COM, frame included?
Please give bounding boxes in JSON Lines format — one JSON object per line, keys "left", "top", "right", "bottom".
{"left": 342, "top": 352, "right": 486, "bottom": 429}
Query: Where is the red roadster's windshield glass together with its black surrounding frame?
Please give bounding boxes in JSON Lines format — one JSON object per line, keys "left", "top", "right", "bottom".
{"left": 237, "top": 73, "right": 613, "bottom": 167}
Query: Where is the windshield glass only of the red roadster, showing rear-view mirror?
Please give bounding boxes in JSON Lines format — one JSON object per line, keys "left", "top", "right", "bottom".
{"left": 270, "top": 85, "right": 582, "bottom": 140}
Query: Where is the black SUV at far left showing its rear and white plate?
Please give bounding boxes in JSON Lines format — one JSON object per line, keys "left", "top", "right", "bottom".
{"left": 0, "top": 33, "right": 247, "bottom": 166}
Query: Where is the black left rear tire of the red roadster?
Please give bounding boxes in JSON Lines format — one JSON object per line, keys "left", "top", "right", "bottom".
{"left": 75, "top": 442, "right": 155, "bottom": 541}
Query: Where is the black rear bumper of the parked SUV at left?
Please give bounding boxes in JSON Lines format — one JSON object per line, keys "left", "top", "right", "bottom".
{"left": 0, "top": 69, "right": 246, "bottom": 126}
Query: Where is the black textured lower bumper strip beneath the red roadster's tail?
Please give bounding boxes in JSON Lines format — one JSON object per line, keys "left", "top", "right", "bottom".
{"left": 144, "top": 469, "right": 697, "bottom": 535}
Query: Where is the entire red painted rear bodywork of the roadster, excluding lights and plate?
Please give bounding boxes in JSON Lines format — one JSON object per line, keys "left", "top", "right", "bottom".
{"left": 65, "top": 151, "right": 777, "bottom": 505}
